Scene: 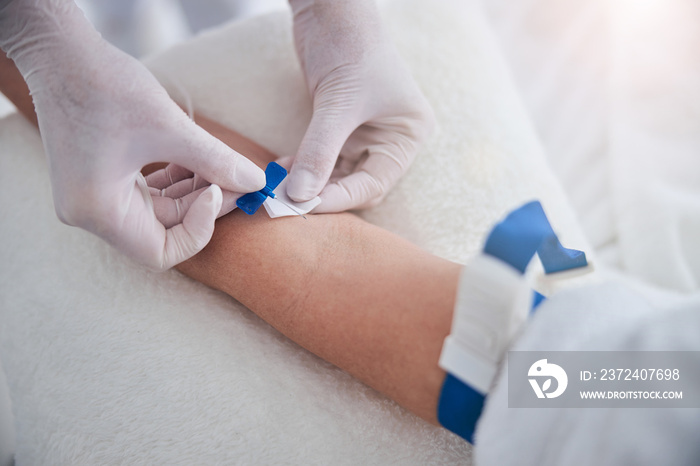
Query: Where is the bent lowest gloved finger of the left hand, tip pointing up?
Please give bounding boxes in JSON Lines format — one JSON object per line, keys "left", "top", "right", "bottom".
{"left": 160, "top": 184, "right": 223, "bottom": 269}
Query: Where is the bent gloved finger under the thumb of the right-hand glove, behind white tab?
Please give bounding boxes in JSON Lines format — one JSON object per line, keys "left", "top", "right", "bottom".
{"left": 314, "top": 144, "right": 412, "bottom": 213}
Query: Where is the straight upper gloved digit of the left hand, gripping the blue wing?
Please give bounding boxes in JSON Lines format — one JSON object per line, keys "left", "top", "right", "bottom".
{"left": 163, "top": 122, "right": 265, "bottom": 193}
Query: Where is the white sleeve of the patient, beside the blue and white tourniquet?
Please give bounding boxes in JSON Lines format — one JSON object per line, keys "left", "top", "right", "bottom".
{"left": 474, "top": 284, "right": 700, "bottom": 466}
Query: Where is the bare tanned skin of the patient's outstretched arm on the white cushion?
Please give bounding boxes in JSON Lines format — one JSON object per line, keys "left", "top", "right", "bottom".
{"left": 0, "top": 56, "right": 460, "bottom": 424}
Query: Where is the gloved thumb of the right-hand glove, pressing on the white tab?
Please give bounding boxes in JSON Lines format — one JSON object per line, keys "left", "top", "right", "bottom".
{"left": 287, "top": 110, "right": 356, "bottom": 202}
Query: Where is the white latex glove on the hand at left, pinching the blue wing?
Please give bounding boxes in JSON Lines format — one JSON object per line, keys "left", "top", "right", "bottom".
{"left": 0, "top": 0, "right": 265, "bottom": 269}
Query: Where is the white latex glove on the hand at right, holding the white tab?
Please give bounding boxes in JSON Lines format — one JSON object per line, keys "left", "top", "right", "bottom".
{"left": 287, "top": 0, "right": 433, "bottom": 212}
